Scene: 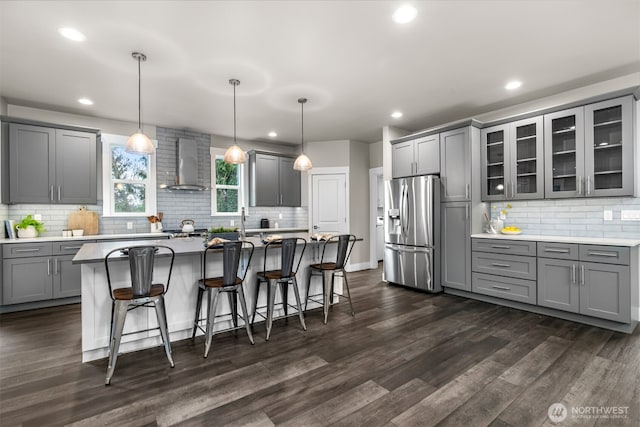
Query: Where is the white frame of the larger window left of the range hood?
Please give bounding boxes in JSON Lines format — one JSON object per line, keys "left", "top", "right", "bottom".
{"left": 101, "top": 133, "right": 158, "bottom": 218}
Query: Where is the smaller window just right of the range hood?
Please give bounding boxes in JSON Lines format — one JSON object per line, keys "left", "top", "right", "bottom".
{"left": 211, "top": 148, "right": 245, "bottom": 215}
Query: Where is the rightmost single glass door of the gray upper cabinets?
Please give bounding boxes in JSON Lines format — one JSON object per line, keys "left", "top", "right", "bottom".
{"left": 584, "top": 96, "right": 634, "bottom": 197}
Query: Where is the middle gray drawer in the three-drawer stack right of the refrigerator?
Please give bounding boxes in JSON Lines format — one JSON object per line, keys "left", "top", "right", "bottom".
{"left": 471, "top": 252, "right": 536, "bottom": 280}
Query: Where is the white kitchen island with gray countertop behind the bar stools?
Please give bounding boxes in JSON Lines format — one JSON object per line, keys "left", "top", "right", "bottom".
{"left": 73, "top": 235, "right": 341, "bottom": 362}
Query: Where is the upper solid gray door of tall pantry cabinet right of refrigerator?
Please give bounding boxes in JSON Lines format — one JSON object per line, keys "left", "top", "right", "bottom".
{"left": 440, "top": 127, "right": 471, "bottom": 202}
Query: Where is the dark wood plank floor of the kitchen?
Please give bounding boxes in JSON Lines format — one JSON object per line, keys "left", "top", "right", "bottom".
{"left": 0, "top": 270, "right": 640, "bottom": 427}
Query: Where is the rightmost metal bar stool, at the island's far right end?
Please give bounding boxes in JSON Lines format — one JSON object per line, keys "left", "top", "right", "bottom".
{"left": 304, "top": 234, "right": 356, "bottom": 324}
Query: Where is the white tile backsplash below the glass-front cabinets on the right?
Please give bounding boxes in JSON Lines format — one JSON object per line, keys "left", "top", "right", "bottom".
{"left": 489, "top": 197, "right": 640, "bottom": 239}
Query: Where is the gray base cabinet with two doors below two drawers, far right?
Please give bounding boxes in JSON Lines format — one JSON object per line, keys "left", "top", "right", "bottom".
{"left": 538, "top": 243, "right": 631, "bottom": 323}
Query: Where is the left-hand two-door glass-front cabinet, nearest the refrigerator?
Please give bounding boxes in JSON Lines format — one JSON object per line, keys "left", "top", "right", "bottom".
{"left": 481, "top": 116, "right": 544, "bottom": 200}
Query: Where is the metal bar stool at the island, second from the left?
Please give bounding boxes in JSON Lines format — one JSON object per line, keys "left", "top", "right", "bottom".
{"left": 192, "top": 240, "right": 255, "bottom": 357}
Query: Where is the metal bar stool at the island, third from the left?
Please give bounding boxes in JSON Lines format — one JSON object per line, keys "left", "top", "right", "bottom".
{"left": 251, "top": 237, "right": 307, "bottom": 341}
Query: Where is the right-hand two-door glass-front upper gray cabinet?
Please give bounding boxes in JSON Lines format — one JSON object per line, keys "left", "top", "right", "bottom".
{"left": 544, "top": 96, "right": 634, "bottom": 198}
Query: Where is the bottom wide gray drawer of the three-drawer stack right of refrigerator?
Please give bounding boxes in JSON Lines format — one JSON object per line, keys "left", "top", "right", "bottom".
{"left": 471, "top": 273, "right": 537, "bottom": 304}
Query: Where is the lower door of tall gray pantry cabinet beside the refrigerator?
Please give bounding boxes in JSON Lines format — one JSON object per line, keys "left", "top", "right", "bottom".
{"left": 440, "top": 202, "right": 471, "bottom": 291}
